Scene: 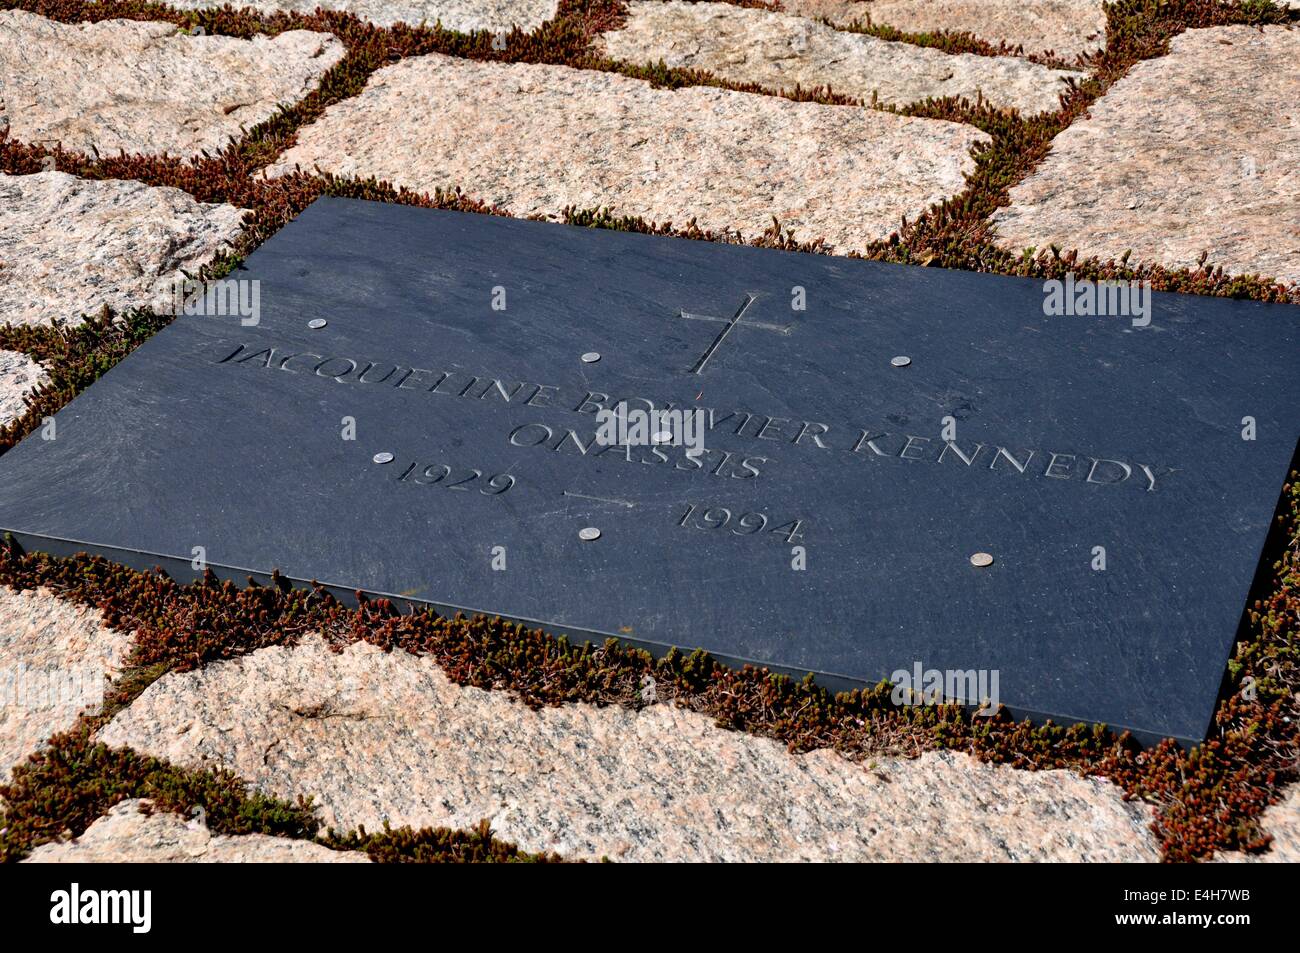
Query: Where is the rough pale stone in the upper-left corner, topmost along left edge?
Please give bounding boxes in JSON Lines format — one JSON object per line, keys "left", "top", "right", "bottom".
{"left": 0, "top": 10, "right": 345, "bottom": 156}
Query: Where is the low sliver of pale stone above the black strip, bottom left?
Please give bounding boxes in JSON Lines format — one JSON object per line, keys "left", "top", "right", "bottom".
{"left": 23, "top": 798, "right": 371, "bottom": 863}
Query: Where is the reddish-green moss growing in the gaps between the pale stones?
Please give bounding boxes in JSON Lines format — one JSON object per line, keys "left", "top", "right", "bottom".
{"left": 0, "top": 0, "right": 1300, "bottom": 861}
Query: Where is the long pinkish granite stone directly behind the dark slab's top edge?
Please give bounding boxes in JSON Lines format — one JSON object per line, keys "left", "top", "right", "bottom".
{"left": 261, "top": 53, "right": 991, "bottom": 254}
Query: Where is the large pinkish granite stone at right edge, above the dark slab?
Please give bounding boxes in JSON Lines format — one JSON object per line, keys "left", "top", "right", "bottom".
{"left": 993, "top": 26, "right": 1300, "bottom": 282}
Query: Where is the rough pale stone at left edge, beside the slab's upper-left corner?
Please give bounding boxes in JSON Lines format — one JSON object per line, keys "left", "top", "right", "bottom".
{"left": 0, "top": 172, "right": 243, "bottom": 324}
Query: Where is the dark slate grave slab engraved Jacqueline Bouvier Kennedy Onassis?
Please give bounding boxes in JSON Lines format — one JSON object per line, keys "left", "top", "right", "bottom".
{"left": 0, "top": 199, "right": 1300, "bottom": 741}
